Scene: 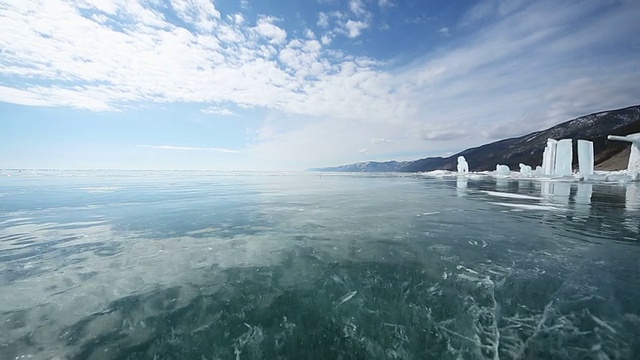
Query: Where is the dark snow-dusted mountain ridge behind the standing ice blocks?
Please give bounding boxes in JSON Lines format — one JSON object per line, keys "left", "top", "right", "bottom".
{"left": 311, "top": 105, "right": 640, "bottom": 172}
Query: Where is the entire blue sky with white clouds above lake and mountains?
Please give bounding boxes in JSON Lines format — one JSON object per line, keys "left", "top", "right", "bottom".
{"left": 0, "top": 0, "right": 640, "bottom": 170}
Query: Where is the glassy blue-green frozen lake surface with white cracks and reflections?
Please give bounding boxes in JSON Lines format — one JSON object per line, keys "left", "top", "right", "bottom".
{"left": 0, "top": 170, "right": 640, "bottom": 360}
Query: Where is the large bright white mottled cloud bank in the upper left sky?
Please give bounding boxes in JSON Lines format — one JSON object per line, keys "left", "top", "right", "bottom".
{"left": 0, "top": 0, "right": 396, "bottom": 122}
